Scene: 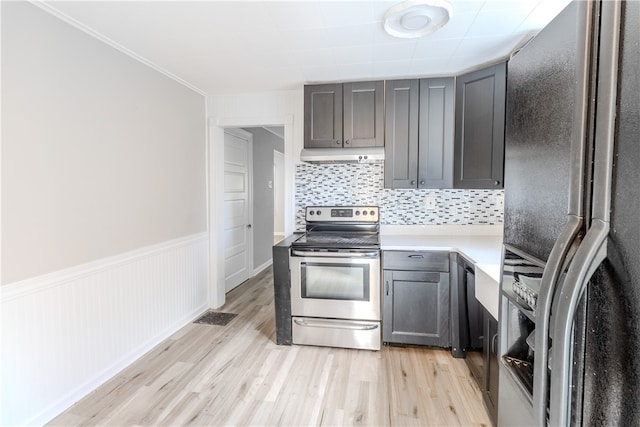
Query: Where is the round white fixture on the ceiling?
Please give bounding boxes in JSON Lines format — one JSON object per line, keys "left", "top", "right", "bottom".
{"left": 383, "top": 0, "right": 453, "bottom": 39}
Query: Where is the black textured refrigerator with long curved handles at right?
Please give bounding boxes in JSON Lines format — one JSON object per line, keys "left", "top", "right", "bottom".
{"left": 498, "top": 0, "right": 640, "bottom": 426}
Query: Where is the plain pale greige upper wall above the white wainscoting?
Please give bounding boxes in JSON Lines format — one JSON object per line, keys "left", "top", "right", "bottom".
{"left": 2, "top": 2, "right": 207, "bottom": 284}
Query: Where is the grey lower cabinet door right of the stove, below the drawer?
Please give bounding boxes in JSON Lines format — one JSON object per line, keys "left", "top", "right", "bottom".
{"left": 382, "top": 270, "right": 450, "bottom": 347}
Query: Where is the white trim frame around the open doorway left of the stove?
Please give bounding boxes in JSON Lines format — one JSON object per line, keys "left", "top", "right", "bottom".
{"left": 207, "top": 115, "right": 295, "bottom": 308}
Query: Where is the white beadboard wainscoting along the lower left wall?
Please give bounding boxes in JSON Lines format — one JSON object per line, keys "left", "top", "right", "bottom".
{"left": 0, "top": 233, "right": 208, "bottom": 425}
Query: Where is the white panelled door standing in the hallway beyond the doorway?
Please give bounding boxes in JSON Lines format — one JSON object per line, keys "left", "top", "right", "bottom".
{"left": 223, "top": 129, "right": 253, "bottom": 292}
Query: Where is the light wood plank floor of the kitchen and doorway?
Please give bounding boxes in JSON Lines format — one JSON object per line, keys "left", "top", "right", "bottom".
{"left": 49, "top": 269, "right": 491, "bottom": 426}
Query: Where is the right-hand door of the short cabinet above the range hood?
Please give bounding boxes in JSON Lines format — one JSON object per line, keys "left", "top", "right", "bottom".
{"left": 343, "top": 81, "right": 384, "bottom": 147}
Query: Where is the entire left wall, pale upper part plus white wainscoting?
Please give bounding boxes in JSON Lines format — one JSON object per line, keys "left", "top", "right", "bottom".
{"left": 0, "top": 2, "right": 209, "bottom": 425}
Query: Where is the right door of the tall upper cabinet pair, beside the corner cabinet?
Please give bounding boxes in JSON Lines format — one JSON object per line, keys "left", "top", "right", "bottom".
{"left": 418, "top": 78, "right": 454, "bottom": 188}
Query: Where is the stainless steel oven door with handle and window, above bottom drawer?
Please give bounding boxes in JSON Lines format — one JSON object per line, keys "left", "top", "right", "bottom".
{"left": 290, "top": 249, "right": 380, "bottom": 321}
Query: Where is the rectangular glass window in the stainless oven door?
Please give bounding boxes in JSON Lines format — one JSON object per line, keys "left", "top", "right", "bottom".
{"left": 301, "top": 262, "right": 370, "bottom": 301}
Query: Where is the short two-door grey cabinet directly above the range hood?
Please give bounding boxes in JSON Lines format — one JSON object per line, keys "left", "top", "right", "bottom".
{"left": 304, "top": 81, "right": 384, "bottom": 148}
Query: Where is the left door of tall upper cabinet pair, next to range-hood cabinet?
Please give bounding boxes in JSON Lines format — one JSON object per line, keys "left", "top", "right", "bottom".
{"left": 384, "top": 80, "right": 419, "bottom": 188}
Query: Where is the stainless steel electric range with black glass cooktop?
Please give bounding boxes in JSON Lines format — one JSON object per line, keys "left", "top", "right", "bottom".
{"left": 290, "top": 206, "right": 381, "bottom": 350}
